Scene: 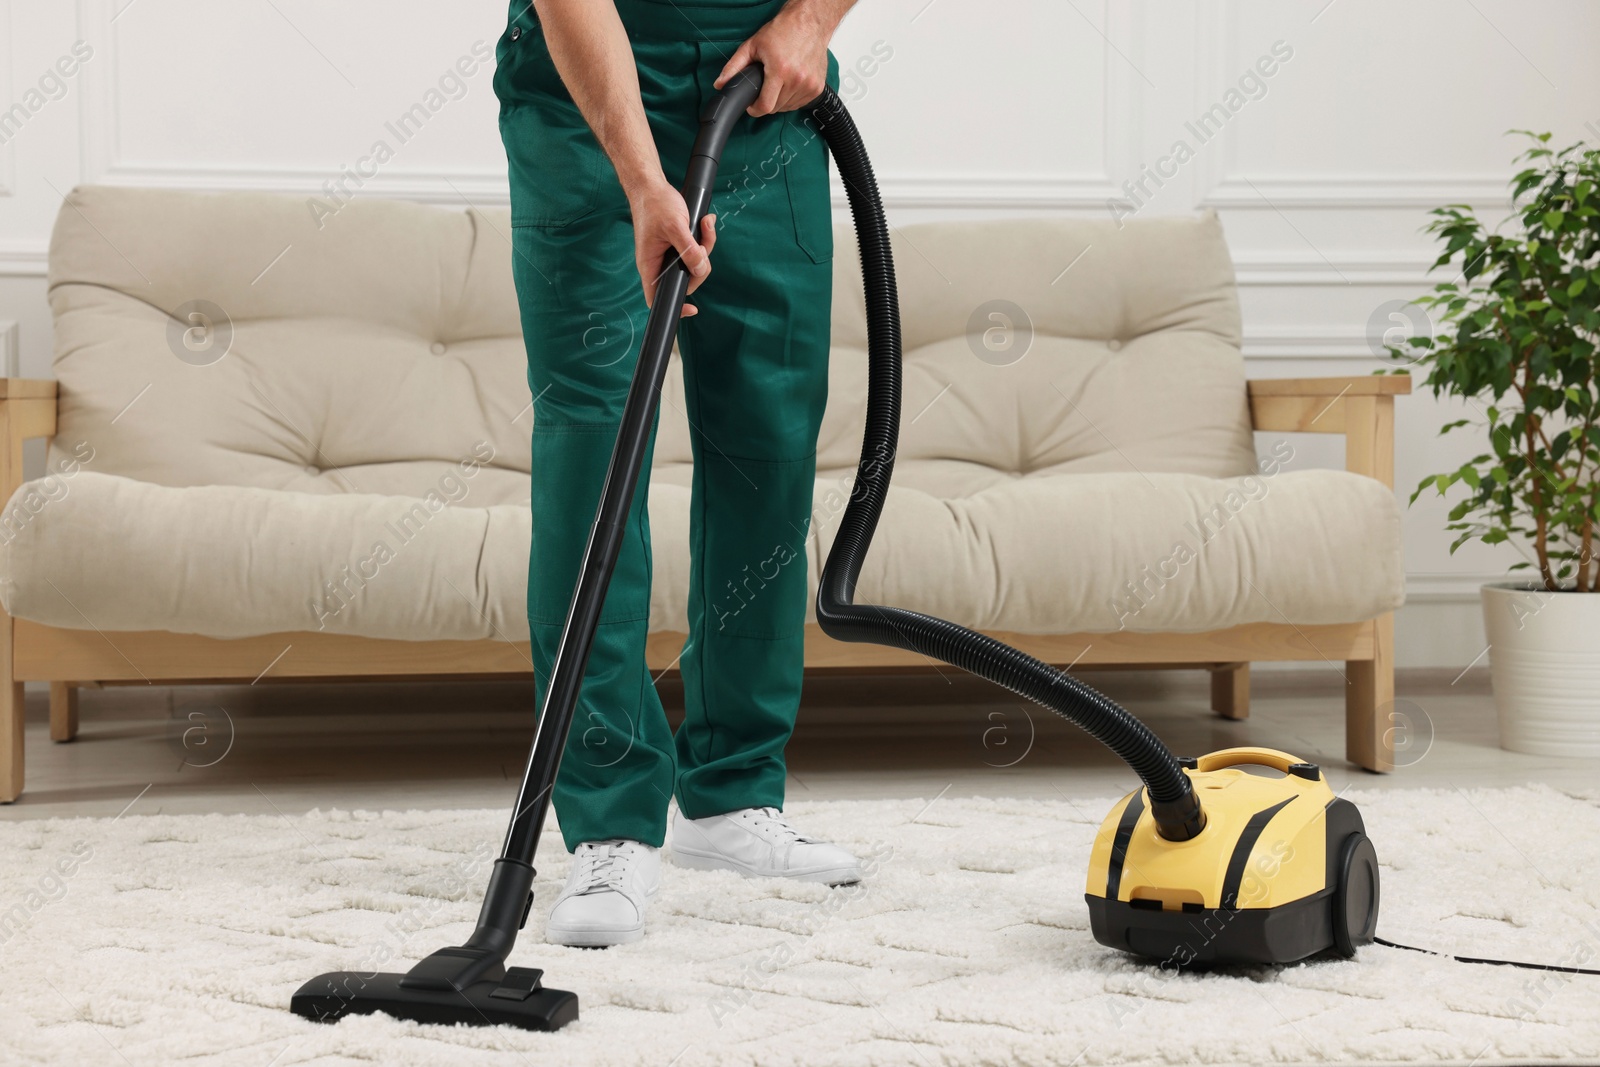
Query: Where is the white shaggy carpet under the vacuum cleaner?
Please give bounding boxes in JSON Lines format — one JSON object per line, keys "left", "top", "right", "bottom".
{"left": 0, "top": 789, "right": 1600, "bottom": 1067}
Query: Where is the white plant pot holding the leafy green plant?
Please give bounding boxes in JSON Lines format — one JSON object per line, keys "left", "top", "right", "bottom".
{"left": 1483, "top": 582, "right": 1600, "bottom": 758}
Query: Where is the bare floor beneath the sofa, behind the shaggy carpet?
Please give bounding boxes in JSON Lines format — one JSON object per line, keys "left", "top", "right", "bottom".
{"left": 0, "top": 669, "right": 1595, "bottom": 819}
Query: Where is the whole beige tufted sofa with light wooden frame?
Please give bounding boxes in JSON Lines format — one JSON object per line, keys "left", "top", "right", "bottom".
{"left": 0, "top": 187, "right": 1408, "bottom": 798}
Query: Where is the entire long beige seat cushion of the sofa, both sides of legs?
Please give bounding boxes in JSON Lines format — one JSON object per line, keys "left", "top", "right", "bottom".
{"left": 0, "top": 462, "right": 1403, "bottom": 641}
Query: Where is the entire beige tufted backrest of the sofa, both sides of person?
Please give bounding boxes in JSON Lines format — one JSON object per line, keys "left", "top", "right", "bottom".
{"left": 50, "top": 186, "right": 1253, "bottom": 504}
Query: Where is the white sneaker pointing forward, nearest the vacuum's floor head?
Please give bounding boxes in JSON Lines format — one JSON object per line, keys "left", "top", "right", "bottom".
{"left": 544, "top": 838, "right": 661, "bottom": 949}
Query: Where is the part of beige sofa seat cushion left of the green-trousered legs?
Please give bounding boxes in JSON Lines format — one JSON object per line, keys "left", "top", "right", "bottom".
{"left": 0, "top": 470, "right": 530, "bottom": 641}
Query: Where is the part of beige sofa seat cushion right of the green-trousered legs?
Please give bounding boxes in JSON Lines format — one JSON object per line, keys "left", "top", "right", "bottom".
{"left": 813, "top": 464, "right": 1405, "bottom": 633}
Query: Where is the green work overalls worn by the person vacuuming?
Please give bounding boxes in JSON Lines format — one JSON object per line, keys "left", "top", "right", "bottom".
{"left": 494, "top": 0, "right": 838, "bottom": 849}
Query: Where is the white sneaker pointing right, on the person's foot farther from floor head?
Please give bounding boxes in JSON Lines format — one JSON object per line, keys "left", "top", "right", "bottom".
{"left": 672, "top": 808, "right": 861, "bottom": 886}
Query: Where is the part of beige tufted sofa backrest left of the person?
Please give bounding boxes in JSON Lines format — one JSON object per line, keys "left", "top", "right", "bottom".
{"left": 50, "top": 186, "right": 531, "bottom": 504}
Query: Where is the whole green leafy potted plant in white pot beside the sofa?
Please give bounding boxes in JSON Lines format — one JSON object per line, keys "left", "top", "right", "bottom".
{"left": 1390, "top": 131, "right": 1600, "bottom": 757}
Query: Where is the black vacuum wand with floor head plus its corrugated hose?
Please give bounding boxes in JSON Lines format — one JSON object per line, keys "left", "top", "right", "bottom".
{"left": 291, "top": 64, "right": 1205, "bottom": 1030}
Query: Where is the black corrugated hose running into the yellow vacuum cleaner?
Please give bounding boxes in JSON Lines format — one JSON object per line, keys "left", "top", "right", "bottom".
{"left": 806, "top": 90, "right": 1205, "bottom": 841}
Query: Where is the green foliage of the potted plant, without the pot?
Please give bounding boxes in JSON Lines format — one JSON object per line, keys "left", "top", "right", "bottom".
{"left": 1395, "top": 131, "right": 1600, "bottom": 573}
